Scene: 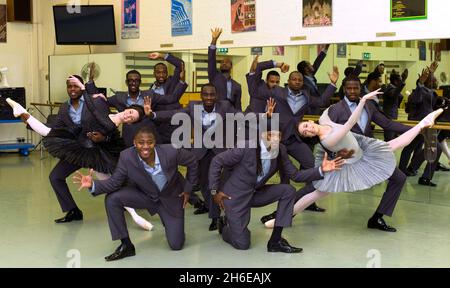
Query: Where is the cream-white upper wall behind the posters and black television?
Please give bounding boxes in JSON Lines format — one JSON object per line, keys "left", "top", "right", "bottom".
{"left": 43, "top": 0, "right": 450, "bottom": 53}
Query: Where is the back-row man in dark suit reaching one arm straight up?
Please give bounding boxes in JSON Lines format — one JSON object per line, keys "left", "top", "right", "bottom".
{"left": 208, "top": 28, "right": 242, "bottom": 111}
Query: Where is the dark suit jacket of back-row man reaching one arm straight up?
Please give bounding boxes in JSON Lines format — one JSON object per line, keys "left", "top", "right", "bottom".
{"left": 208, "top": 47, "right": 242, "bottom": 111}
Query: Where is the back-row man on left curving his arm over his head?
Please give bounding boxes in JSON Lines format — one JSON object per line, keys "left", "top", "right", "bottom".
{"left": 148, "top": 52, "right": 184, "bottom": 144}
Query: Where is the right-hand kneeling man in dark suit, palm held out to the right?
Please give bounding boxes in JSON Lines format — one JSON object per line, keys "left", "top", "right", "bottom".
{"left": 209, "top": 131, "right": 343, "bottom": 253}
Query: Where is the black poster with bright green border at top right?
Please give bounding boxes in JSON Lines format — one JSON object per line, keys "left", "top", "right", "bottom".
{"left": 391, "top": 0, "right": 428, "bottom": 21}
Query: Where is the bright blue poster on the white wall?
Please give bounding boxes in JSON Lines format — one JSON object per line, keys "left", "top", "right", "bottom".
{"left": 171, "top": 0, "right": 192, "bottom": 36}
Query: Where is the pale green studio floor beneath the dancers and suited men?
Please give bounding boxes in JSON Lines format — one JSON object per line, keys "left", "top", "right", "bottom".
{"left": 0, "top": 153, "right": 450, "bottom": 268}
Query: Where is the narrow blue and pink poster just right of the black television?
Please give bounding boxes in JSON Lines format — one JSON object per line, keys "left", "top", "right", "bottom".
{"left": 122, "top": 0, "right": 139, "bottom": 39}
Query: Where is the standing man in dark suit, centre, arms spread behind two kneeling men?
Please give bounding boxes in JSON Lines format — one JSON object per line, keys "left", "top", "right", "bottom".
{"left": 150, "top": 83, "right": 246, "bottom": 231}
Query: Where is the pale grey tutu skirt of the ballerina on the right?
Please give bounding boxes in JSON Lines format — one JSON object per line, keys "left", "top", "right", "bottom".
{"left": 313, "top": 133, "right": 397, "bottom": 193}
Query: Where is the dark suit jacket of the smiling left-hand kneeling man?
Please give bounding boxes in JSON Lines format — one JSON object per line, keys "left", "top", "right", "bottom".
{"left": 93, "top": 144, "right": 198, "bottom": 217}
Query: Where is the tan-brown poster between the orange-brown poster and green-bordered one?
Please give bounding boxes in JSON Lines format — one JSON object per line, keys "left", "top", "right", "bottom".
{"left": 303, "top": 0, "right": 333, "bottom": 27}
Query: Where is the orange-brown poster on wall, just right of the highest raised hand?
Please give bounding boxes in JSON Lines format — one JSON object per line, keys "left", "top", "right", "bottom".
{"left": 231, "top": 0, "right": 256, "bottom": 32}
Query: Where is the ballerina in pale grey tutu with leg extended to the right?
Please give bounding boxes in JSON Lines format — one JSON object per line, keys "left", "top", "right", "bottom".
{"left": 265, "top": 89, "right": 444, "bottom": 228}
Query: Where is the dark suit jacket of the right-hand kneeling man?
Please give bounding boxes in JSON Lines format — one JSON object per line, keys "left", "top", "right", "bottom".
{"left": 209, "top": 144, "right": 323, "bottom": 199}
